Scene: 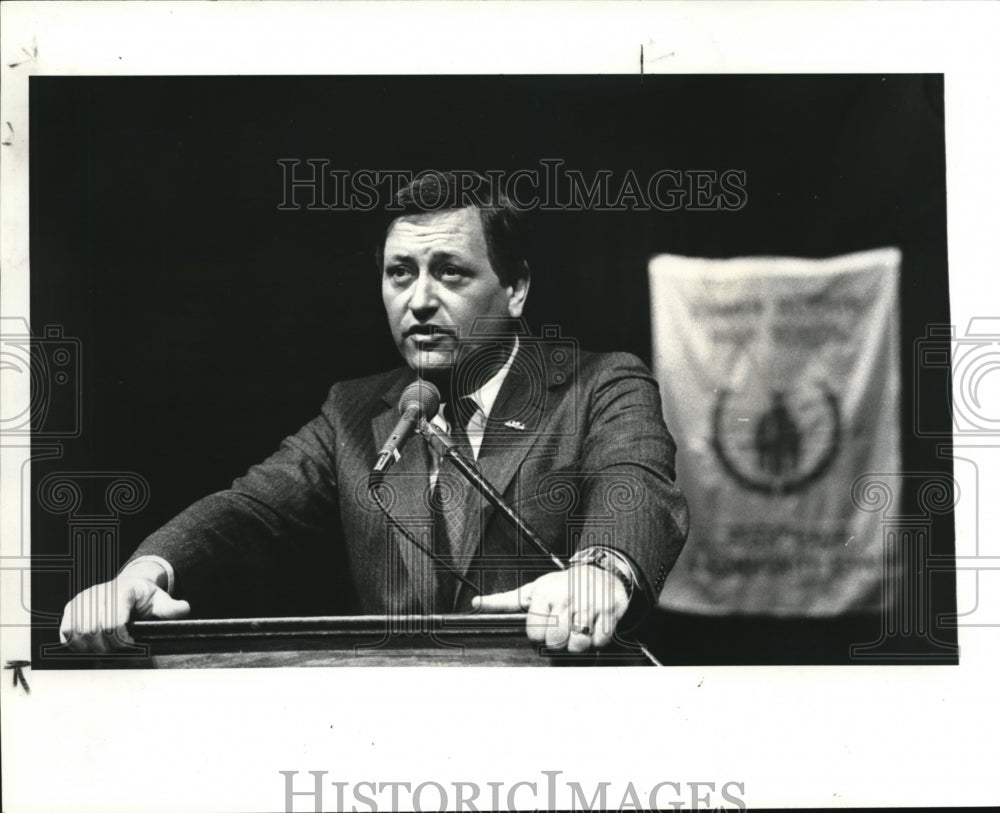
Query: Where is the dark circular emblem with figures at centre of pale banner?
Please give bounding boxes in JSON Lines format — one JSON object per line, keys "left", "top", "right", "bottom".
{"left": 712, "top": 384, "right": 841, "bottom": 494}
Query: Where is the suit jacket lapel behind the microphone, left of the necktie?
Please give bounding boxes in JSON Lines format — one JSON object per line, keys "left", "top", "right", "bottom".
{"left": 372, "top": 371, "right": 436, "bottom": 612}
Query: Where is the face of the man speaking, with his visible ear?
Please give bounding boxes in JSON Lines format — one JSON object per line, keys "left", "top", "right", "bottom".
{"left": 382, "top": 207, "right": 528, "bottom": 377}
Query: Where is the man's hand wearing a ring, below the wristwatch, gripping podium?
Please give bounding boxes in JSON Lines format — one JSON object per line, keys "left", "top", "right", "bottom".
{"left": 472, "top": 565, "right": 628, "bottom": 652}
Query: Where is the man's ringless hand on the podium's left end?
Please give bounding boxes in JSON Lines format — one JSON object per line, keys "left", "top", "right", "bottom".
{"left": 59, "top": 563, "right": 191, "bottom": 652}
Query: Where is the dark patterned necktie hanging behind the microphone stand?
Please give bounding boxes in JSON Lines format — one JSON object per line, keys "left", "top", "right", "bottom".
{"left": 431, "top": 403, "right": 473, "bottom": 612}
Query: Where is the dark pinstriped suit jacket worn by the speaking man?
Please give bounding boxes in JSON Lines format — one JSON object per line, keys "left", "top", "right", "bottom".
{"left": 134, "top": 341, "right": 688, "bottom": 616}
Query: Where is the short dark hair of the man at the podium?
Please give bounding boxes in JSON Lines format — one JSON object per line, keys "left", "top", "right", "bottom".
{"left": 375, "top": 171, "right": 528, "bottom": 286}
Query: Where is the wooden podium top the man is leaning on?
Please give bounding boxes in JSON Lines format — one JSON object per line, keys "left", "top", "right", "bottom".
{"left": 101, "top": 613, "right": 648, "bottom": 669}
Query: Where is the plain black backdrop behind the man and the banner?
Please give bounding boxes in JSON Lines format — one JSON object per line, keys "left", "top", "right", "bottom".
{"left": 30, "top": 75, "right": 954, "bottom": 664}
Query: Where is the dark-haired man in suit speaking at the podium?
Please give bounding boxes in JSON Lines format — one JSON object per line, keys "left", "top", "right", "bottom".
{"left": 60, "top": 170, "right": 687, "bottom": 652}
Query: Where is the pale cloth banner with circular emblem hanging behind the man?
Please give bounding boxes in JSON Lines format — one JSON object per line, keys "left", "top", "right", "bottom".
{"left": 649, "top": 248, "right": 900, "bottom": 616}
